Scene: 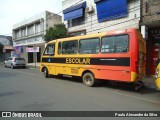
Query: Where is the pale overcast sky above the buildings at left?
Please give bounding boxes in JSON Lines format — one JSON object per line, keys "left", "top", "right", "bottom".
{"left": 0, "top": 0, "right": 63, "bottom": 36}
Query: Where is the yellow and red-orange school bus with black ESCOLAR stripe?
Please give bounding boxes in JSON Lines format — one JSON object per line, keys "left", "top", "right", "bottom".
{"left": 40, "top": 29, "right": 146, "bottom": 86}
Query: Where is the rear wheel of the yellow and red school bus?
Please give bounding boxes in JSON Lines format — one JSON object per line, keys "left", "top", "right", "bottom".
{"left": 82, "top": 72, "right": 95, "bottom": 87}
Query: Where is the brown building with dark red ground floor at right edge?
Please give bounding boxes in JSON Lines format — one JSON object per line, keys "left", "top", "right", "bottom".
{"left": 141, "top": 0, "right": 160, "bottom": 75}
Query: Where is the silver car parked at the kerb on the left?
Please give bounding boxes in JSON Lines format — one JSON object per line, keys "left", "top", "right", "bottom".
{"left": 4, "top": 57, "right": 26, "bottom": 69}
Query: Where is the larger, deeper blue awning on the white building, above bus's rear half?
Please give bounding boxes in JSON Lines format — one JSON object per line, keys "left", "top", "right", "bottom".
{"left": 94, "top": 0, "right": 127, "bottom": 22}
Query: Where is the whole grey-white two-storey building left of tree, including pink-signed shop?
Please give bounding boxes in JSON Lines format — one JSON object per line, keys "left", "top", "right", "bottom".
{"left": 12, "top": 11, "right": 62, "bottom": 63}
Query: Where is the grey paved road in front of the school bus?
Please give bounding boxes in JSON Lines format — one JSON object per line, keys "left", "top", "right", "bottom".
{"left": 0, "top": 65, "right": 160, "bottom": 119}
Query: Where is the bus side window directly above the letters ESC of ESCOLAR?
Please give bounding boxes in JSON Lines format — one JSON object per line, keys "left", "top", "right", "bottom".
{"left": 62, "top": 40, "right": 78, "bottom": 54}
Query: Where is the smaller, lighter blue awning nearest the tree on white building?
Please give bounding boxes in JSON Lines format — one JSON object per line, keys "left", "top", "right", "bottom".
{"left": 63, "top": 2, "right": 86, "bottom": 20}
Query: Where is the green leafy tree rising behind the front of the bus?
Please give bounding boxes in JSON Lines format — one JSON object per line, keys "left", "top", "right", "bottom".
{"left": 43, "top": 24, "right": 67, "bottom": 42}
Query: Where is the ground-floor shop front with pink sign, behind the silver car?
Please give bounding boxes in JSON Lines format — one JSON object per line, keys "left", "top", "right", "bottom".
{"left": 14, "top": 37, "right": 45, "bottom": 63}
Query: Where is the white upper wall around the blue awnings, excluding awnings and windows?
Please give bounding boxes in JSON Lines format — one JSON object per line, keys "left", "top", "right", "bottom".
{"left": 62, "top": 0, "right": 140, "bottom": 34}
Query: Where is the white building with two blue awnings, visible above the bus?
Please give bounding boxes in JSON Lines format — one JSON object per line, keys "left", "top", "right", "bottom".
{"left": 62, "top": 0, "right": 140, "bottom": 36}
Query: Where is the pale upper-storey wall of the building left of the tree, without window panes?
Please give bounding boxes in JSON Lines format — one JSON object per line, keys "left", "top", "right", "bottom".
{"left": 12, "top": 11, "right": 62, "bottom": 46}
